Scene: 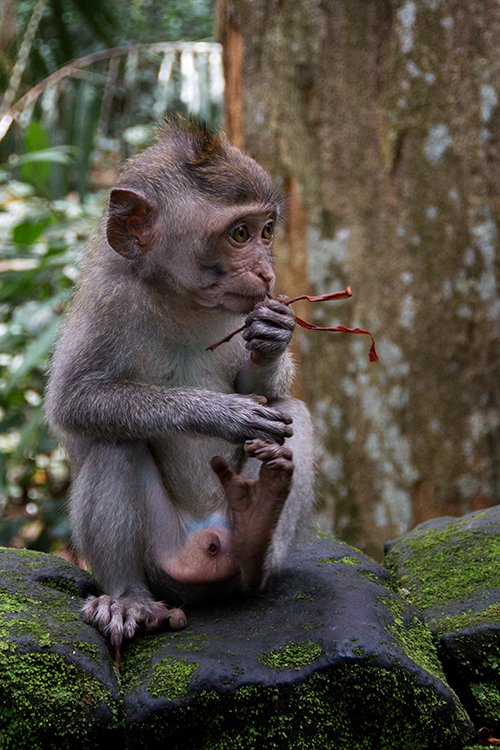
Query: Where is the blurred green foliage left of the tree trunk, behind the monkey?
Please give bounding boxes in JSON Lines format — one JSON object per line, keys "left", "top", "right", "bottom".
{"left": 0, "top": 0, "right": 220, "bottom": 551}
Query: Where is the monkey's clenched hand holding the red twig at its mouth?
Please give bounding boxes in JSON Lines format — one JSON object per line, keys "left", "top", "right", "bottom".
{"left": 242, "top": 299, "right": 295, "bottom": 364}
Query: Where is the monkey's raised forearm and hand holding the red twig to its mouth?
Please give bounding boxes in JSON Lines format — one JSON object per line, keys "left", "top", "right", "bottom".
{"left": 236, "top": 299, "right": 295, "bottom": 398}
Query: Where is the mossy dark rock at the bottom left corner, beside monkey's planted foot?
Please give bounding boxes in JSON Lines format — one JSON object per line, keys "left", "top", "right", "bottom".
{"left": 0, "top": 549, "right": 122, "bottom": 750}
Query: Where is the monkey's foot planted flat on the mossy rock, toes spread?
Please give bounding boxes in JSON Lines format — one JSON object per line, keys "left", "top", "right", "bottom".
{"left": 82, "top": 594, "right": 187, "bottom": 652}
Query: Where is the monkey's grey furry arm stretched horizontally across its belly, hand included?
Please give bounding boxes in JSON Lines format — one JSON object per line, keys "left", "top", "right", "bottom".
{"left": 46, "top": 376, "right": 292, "bottom": 443}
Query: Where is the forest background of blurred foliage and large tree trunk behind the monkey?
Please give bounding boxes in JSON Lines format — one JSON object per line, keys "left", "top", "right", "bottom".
{"left": 0, "top": 0, "right": 500, "bottom": 557}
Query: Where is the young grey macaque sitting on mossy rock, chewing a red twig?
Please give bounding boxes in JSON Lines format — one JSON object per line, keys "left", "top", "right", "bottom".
{"left": 46, "top": 117, "right": 313, "bottom": 650}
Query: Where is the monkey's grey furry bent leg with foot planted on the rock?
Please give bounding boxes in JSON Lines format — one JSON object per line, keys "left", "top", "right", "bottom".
{"left": 70, "top": 443, "right": 186, "bottom": 649}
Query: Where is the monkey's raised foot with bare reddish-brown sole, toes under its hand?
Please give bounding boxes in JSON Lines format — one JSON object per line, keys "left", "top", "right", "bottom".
{"left": 212, "top": 440, "right": 293, "bottom": 589}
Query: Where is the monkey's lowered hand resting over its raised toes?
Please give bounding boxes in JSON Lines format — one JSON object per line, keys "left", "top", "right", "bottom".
{"left": 215, "top": 394, "right": 293, "bottom": 445}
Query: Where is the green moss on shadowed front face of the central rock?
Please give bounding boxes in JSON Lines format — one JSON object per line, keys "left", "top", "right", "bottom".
{"left": 129, "top": 664, "right": 469, "bottom": 750}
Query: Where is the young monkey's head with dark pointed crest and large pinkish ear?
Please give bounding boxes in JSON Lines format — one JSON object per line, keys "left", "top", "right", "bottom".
{"left": 106, "top": 117, "right": 282, "bottom": 313}
